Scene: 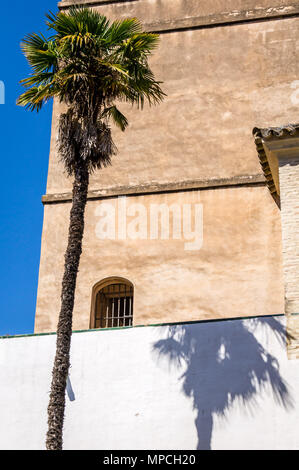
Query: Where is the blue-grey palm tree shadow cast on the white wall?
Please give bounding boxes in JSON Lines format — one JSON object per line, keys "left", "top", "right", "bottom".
{"left": 153, "top": 317, "right": 293, "bottom": 450}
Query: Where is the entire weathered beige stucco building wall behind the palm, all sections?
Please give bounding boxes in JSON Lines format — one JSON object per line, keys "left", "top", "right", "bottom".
{"left": 36, "top": 0, "right": 299, "bottom": 332}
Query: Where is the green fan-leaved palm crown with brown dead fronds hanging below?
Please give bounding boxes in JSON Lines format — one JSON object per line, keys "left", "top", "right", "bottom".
{"left": 18, "top": 7, "right": 164, "bottom": 175}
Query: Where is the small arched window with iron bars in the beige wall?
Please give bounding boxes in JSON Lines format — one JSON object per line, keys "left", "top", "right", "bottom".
{"left": 94, "top": 282, "right": 133, "bottom": 328}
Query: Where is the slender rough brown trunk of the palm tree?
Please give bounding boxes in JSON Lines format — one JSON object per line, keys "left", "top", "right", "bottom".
{"left": 46, "top": 160, "right": 89, "bottom": 450}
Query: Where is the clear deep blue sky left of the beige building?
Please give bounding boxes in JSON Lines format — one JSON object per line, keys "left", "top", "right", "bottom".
{"left": 0, "top": 0, "right": 57, "bottom": 335}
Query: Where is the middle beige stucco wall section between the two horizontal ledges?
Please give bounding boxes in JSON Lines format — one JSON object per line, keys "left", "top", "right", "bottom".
{"left": 47, "top": 16, "right": 299, "bottom": 194}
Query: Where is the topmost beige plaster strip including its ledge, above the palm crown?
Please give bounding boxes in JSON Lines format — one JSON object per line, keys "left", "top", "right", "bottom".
{"left": 59, "top": 0, "right": 299, "bottom": 31}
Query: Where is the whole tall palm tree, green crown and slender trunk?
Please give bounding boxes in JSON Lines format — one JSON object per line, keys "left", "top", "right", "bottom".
{"left": 18, "top": 7, "right": 164, "bottom": 450}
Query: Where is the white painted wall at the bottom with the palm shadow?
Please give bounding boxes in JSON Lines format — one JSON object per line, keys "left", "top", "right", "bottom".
{"left": 0, "top": 317, "right": 299, "bottom": 450}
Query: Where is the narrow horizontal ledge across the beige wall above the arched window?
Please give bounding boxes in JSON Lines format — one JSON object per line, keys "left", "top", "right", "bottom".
{"left": 42, "top": 174, "right": 266, "bottom": 204}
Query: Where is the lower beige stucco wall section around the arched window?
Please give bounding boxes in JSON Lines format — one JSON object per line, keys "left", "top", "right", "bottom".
{"left": 36, "top": 186, "right": 284, "bottom": 332}
